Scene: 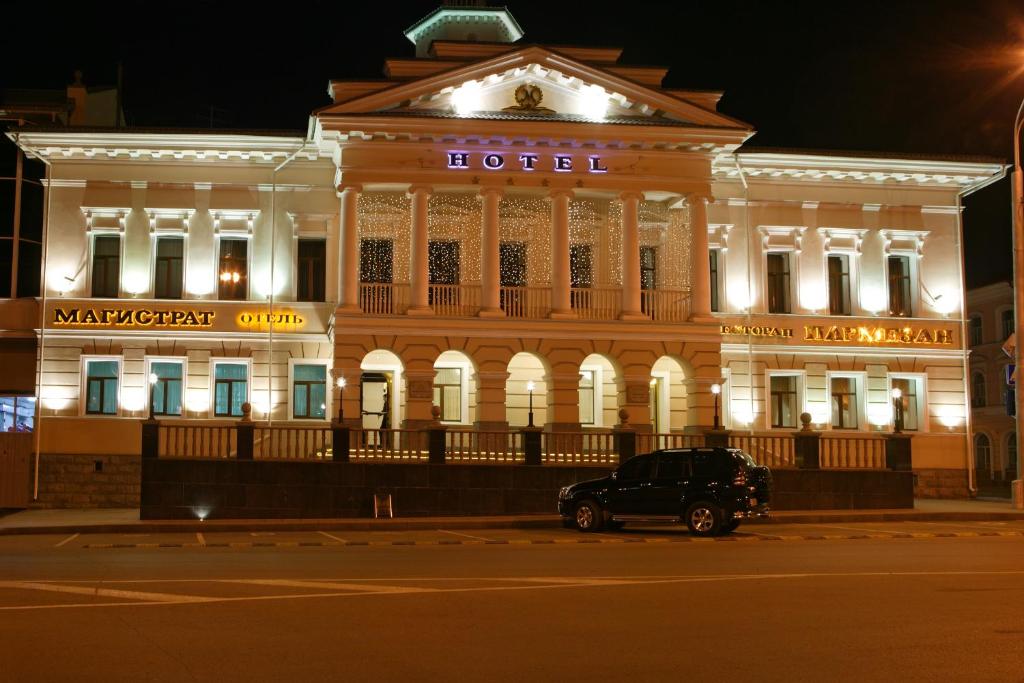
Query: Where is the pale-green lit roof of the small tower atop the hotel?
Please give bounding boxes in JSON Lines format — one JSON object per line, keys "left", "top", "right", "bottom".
{"left": 406, "top": 0, "right": 522, "bottom": 57}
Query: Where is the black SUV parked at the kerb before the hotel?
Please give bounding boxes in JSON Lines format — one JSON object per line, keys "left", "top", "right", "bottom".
{"left": 558, "top": 449, "right": 771, "bottom": 536}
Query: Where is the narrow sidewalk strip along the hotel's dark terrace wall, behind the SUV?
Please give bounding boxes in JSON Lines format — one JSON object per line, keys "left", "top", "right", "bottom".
{"left": 0, "top": 500, "right": 1024, "bottom": 536}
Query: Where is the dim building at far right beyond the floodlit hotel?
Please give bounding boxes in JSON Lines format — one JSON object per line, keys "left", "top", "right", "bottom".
{"left": 967, "top": 283, "right": 1017, "bottom": 497}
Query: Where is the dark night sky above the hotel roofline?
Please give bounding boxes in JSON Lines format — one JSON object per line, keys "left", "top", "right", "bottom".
{"left": 0, "top": 0, "right": 1024, "bottom": 285}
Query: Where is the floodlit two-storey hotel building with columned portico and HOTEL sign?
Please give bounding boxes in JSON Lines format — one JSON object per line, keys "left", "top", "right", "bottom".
{"left": 4, "top": 7, "right": 1002, "bottom": 503}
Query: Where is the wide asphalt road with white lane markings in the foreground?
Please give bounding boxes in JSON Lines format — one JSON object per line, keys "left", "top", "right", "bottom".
{"left": 0, "top": 521, "right": 1024, "bottom": 682}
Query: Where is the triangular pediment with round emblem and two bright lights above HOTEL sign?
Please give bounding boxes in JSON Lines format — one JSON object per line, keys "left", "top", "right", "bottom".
{"left": 316, "top": 46, "right": 750, "bottom": 129}
